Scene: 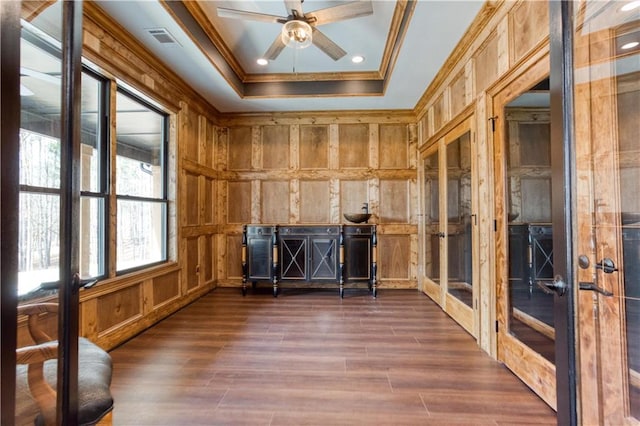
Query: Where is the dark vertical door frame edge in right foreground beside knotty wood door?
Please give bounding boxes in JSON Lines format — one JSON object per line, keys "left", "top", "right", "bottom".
{"left": 549, "top": 1, "right": 578, "bottom": 425}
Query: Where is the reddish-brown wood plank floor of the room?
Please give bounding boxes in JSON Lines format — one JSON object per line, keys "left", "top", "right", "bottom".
{"left": 111, "top": 288, "right": 556, "bottom": 425}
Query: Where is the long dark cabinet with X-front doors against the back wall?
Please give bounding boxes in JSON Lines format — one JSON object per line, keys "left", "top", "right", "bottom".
{"left": 242, "top": 225, "right": 377, "bottom": 297}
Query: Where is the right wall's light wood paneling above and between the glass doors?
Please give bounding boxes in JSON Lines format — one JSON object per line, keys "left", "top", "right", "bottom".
{"left": 416, "top": 1, "right": 549, "bottom": 356}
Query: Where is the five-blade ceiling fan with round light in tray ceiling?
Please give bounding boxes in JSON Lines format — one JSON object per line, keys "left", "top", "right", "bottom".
{"left": 218, "top": 0, "right": 373, "bottom": 61}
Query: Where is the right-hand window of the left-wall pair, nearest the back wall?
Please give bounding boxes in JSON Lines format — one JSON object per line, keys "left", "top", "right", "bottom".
{"left": 116, "top": 90, "right": 167, "bottom": 272}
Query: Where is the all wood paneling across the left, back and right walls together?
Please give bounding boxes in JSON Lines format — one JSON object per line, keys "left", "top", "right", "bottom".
{"left": 17, "top": 1, "right": 548, "bottom": 360}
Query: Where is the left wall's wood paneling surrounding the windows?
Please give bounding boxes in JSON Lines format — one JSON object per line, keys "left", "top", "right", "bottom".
{"left": 18, "top": 2, "right": 225, "bottom": 349}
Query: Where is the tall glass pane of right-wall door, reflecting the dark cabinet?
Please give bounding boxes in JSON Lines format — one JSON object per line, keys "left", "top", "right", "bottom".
{"left": 505, "top": 100, "right": 555, "bottom": 362}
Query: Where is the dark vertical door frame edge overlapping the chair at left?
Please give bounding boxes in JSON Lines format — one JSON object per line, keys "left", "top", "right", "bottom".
{"left": 56, "top": 0, "right": 83, "bottom": 424}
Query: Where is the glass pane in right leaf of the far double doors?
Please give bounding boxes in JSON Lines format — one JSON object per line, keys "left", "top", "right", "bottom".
{"left": 447, "top": 132, "right": 473, "bottom": 307}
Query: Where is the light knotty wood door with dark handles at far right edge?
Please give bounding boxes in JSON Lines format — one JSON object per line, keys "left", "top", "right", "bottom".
{"left": 570, "top": 2, "right": 640, "bottom": 425}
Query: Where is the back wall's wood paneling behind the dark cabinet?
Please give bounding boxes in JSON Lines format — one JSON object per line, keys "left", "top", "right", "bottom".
{"left": 216, "top": 112, "right": 417, "bottom": 288}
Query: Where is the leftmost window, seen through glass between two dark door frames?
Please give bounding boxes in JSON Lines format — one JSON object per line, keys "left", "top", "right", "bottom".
{"left": 18, "top": 26, "right": 62, "bottom": 295}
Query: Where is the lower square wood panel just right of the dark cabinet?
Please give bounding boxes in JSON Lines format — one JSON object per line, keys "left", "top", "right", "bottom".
{"left": 378, "top": 235, "right": 411, "bottom": 280}
